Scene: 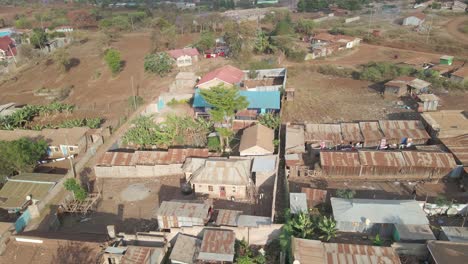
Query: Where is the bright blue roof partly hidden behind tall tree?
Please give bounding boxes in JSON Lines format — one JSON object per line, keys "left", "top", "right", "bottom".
{"left": 193, "top": 89, "right": 281, "bottom": 110}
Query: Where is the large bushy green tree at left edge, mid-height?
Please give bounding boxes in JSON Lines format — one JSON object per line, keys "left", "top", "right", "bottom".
{"left": 0, "top": 138, "right": 47, "bottom": 176}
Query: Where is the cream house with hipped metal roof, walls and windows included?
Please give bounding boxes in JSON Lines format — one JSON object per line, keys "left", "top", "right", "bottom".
{"left": 189, "top": 159, "right": 253, "bottom": 200}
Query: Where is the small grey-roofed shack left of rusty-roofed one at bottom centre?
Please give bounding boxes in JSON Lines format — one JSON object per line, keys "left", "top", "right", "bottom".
{"left": 169, "top": 233, "right": 201, "bottom": 264}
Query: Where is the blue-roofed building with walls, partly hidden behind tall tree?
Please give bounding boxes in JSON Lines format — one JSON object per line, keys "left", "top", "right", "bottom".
{"left": 192, "top": 89, "right": 281, "bottom": 114}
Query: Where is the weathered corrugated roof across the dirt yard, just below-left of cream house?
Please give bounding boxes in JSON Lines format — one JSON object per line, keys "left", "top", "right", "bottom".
{"left": 157, "top": 201, "right": 211, "bottom": 219}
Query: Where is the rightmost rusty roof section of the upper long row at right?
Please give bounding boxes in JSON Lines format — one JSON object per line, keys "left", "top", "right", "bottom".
{"left": 379, "top": 120, "right": 431, "bottom": 141}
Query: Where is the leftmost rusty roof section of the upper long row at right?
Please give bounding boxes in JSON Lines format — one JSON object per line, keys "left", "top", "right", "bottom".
{"left": 305, "top": 124, "right": 343, "bottom": 145}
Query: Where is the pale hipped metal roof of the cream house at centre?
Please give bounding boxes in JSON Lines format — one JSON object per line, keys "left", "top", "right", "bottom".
{"left": 190, "top": 159, "right": 251, "bottom": 186}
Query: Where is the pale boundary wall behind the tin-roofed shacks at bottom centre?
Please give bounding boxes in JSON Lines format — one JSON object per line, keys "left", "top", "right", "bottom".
{"left": 167, "top": 224, "right": 283, "bottom": 245}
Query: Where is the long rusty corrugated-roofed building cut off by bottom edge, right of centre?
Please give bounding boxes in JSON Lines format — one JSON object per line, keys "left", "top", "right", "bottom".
{"left": 291, "top": 237, "right": 400, "bottom": 264}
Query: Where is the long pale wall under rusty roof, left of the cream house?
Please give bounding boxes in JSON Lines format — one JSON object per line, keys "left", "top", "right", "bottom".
{"left": 94, "top": 164, "right": 184, "bottom": 178}
